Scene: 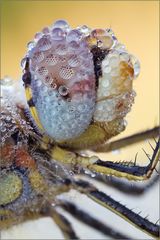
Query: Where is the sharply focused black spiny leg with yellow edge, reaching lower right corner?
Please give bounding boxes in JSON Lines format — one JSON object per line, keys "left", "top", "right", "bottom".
{"left": 75, "top": 180, "right": 160, "bottom": 237}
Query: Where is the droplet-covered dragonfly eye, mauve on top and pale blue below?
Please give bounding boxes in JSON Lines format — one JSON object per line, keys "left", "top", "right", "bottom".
{"left": 25, "top": 21, "right": 96, "bottom": 141}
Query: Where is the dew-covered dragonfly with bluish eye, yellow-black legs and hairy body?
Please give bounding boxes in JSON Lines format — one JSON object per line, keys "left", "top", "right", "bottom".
{"left": 0, "top": 20, "right": 160, "bottom": 239}
